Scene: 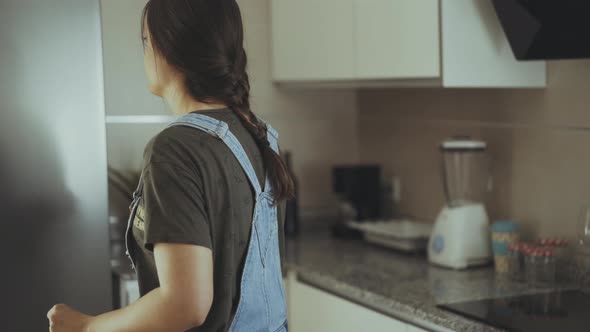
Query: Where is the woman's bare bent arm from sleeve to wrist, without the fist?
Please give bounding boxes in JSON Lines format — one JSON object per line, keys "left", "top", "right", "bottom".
{"left": 87, "top": 243, "right": 213, "bottom": 332}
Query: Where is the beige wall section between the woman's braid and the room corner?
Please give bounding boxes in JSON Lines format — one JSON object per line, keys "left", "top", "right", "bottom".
{"left": 238, "top": 0, "right": 359, "bottom": 209}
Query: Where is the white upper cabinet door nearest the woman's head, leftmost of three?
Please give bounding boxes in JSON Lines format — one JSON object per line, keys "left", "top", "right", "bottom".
{"left": 271, "top": 0, "right": 354, "bottom": 81}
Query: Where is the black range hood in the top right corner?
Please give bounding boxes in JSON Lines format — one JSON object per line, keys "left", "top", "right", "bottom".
{"left": 492, "top": 0, "right": 590, "bottom": 60}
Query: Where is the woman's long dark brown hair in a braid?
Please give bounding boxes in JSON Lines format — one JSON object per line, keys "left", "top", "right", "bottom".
{"left": 142, "top": 0, "right": 294, "bottom": 203}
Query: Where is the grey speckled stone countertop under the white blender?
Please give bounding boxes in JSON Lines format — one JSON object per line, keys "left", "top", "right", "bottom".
{"left": 286, "top": 230, "right": 576, "bottom": 332}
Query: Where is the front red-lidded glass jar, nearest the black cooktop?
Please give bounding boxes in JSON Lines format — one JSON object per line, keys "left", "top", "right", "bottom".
{"left": 525, "top": 248, "right": 555, "bottom": 289}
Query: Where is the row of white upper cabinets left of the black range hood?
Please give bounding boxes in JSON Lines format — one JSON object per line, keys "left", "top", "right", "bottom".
{"left": 271, "top": 0, "right": 546, "bottom": 88}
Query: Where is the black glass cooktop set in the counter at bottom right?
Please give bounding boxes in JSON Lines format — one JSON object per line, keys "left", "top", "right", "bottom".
{"left": 439, "top": 291, "right": 590, "bottom": 332}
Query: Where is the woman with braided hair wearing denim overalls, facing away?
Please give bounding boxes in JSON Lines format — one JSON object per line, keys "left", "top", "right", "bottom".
{"left": 48, "top": 0, "right": 293, "bottom": 332}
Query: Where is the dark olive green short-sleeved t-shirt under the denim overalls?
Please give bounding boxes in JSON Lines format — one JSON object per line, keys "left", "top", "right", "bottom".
{"left": 130, "top": 109, "right": 284, "bottom": 332}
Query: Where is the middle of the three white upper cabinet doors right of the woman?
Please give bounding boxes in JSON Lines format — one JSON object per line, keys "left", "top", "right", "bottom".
{"left": 354, "top": 0, "right": 440, "bottom": 79}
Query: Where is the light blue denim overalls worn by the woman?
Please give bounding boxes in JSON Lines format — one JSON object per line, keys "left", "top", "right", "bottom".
{"left": 126, "top": 113, "right": 287, "bottom": 332}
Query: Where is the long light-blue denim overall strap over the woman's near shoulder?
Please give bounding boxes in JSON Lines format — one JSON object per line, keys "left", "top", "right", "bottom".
{"left": 168, "top": 113, "right": 262, "bottom": 197}
